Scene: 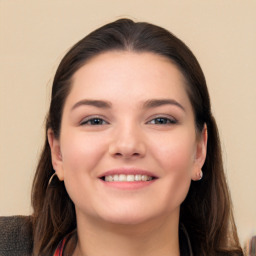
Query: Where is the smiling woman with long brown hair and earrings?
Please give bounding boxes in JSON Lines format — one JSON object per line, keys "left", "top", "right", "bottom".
{"left": 32, "top": 19, "right": 242, "bottom": 256}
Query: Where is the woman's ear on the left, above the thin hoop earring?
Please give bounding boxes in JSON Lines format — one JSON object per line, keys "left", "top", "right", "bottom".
{"left": 47, "top": 129, "right": 64, "bottom": 180}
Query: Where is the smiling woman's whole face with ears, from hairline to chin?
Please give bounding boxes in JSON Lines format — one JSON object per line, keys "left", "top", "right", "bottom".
{"left": 49, "top": 51, "right": 207, "bottom": 224}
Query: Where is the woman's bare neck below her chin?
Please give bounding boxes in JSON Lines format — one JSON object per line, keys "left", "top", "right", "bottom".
{"left": 73, "top": 213, "right": 180, "bottom": 256}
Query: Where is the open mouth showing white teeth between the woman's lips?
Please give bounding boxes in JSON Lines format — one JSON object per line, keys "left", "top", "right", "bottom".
{"left": 100, "top": 174, "right": 157, "bottom": 182}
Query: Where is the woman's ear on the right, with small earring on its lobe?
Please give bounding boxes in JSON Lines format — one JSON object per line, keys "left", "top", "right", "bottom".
{"left": 192, "top": 124, "right": 208, "bottom": 181}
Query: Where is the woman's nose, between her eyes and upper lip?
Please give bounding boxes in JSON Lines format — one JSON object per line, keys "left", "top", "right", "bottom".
{"left": 109, "top": 124, "right": 146, "bottom": 159}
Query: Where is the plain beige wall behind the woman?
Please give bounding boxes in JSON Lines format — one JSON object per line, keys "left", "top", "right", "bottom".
{"left": 0, "top": 0, "right": 256, "bottom": 246}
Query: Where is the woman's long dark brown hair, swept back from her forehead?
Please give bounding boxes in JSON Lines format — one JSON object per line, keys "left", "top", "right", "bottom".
{"left": 32, "top": 19, "right": 242, "bottom": 256}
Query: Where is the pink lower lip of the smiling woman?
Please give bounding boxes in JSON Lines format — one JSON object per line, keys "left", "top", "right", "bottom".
{"left": 100, "top": 179, "right": 156, "bottom": 190}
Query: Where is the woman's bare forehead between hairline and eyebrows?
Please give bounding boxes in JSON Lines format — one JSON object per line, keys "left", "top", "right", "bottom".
{"left": 67, "top": 51, "right": 191, "bottom": 108}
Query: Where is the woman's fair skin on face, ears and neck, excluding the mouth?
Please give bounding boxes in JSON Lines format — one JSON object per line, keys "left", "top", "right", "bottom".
{"left": 48, "top": 51, "right": 207, "bottom": 256}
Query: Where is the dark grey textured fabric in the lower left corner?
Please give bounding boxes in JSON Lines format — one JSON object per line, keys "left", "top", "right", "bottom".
{"left": 0, "top": 216, "right": 33, "bottom": 256}
